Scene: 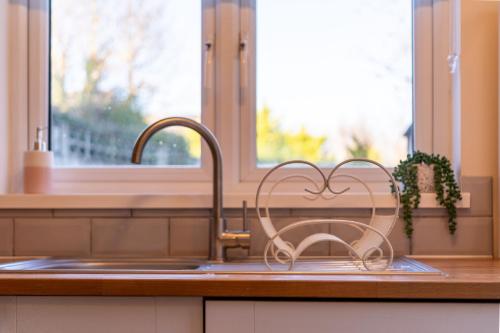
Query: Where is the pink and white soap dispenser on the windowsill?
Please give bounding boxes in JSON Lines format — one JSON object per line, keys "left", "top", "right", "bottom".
{"left": 24, "top": 127, "right": 54, "bottom": 193}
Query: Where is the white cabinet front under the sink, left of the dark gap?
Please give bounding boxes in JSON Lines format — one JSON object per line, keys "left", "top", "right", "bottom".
{"left": 0, "top": 297, "right": 203, "bottom": 333}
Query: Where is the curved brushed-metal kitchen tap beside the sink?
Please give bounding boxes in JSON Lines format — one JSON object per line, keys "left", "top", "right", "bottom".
{"left": 132, "top": 117, "right": 250, "bottom": 262}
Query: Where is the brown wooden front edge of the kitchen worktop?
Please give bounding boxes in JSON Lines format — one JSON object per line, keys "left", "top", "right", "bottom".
{"left": 0, "top": 276, "right": 500, "bottom": 301}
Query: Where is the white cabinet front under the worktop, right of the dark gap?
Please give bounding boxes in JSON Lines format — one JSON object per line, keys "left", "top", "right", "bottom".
{"left": 205, "top": 301, "right": 499, "bottom": 333}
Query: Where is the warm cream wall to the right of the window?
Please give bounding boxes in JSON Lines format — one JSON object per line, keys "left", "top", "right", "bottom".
{"left": 462, "top": 0, "right": 500, "bottom": 257}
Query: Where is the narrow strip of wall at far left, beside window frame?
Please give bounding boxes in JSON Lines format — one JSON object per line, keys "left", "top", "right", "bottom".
{"left": 0, "top": 0, "right": 8, "bottom": 193}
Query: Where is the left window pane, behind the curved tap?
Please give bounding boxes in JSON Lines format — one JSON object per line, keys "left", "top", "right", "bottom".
{"left": 51, "top": 0, "right": 201, "bottom": 166}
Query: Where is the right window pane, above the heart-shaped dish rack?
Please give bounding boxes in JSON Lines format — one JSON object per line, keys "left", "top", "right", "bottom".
{"left": 256, "top": 0, "right": 413, "bottom": 167}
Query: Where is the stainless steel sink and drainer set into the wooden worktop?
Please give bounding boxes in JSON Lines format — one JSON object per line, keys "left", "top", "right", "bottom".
{"left": 0, "top": 257, "right": 442, "bottom": 275}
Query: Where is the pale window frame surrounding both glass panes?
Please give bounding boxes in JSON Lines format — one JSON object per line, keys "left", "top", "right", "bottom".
{"left": 9, "top": 0, "right": 460, "bottom": 194}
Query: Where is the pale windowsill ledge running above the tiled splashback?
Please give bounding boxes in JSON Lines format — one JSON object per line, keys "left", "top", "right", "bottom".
{"left": 0, "top": 193, "right": 471, "bottom": 209}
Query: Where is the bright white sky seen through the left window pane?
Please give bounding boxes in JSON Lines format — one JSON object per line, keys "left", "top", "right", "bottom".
{"left": 52, "top": 0, "right": 201, "bottom": 121}
